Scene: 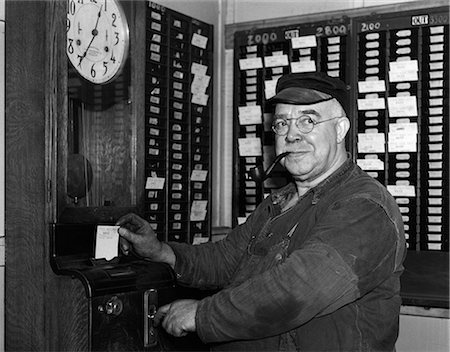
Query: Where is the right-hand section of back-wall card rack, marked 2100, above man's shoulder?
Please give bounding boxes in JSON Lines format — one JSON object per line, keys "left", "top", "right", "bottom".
{"left": 353, "top": 8, "right": 449, "bottom": 251}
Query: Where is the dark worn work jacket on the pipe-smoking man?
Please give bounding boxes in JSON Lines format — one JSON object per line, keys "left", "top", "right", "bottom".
{"left": 170, "top": 160, "right": 406, "bottom": 351}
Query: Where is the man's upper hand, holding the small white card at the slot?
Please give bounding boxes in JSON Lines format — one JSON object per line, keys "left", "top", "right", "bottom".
{"left": 116, "top": 214, "right": 176, "bottom": 268}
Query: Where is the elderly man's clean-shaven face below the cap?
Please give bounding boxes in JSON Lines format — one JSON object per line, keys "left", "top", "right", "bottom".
{"left": 274, "top": 99, "right": 348, "bottom": 182}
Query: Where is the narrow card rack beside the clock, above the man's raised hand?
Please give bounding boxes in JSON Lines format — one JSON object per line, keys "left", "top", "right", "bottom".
{"left": 144, "top": 1, "right": 213, "bottom": 243}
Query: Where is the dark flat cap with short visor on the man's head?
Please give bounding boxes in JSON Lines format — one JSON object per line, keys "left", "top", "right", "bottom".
{"left": 267, "top": 72, "right": 349, "bottom": 113}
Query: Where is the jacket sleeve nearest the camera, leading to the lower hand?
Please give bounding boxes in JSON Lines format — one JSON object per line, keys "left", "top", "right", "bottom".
{"left": 196, "top": 198, "right": 398, "bottom": 342}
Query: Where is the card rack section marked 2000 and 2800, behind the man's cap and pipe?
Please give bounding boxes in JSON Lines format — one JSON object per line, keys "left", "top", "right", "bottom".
{"left": 233, "top": 18, "right": 349, "bottom": 223}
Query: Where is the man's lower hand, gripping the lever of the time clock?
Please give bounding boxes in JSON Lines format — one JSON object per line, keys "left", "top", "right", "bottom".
{"left": 155, "top": 299, "right": 198, "bottom": 337}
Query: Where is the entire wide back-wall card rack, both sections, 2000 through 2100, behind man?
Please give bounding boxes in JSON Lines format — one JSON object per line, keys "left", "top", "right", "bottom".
{"left": 233, "top": 6, "right": 450, "bottom": 252}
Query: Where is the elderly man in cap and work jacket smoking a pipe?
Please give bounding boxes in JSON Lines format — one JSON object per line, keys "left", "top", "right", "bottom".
{"left": 117, "top": 73, "right": 406, "bottom": 351}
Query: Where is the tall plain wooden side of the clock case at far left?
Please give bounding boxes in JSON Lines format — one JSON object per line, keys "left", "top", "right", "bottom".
{"left": 5, "top": 1, "right": 45, "bottom": 351}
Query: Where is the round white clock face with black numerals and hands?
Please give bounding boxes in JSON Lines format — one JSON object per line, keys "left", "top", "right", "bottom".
{"left": 67, "top": 0, "right": 129, "bottom": 84}
